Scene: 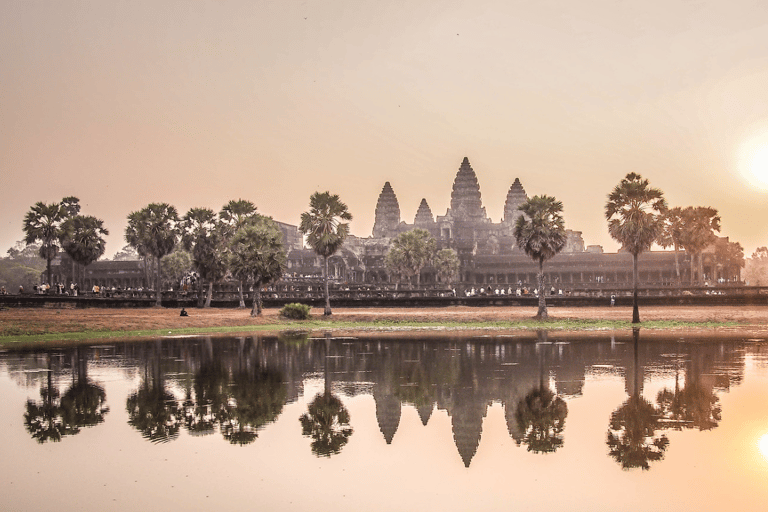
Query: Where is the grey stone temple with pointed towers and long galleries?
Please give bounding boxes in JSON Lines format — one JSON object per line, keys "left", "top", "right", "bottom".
{"left": 289, "top": 157, "right": 739, "bottom": 291}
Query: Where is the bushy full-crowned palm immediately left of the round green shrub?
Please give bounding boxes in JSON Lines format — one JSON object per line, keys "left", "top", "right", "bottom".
{"left": 229, "top": 216, "right": 287, "bottom": 316}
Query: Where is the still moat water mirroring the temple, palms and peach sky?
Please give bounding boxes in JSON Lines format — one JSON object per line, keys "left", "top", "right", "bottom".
{"left": 0, "top": 332, "right": 768, "bottom": 511}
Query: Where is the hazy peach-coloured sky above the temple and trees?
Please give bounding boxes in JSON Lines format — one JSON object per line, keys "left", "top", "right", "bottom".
{"left": 0, "top": 0, "right": 768, "bottom": 256}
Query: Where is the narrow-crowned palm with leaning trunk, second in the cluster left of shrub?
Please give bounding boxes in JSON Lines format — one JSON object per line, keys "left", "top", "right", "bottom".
{"left": 181, "top": 208, "right": 227, "bottom": 308}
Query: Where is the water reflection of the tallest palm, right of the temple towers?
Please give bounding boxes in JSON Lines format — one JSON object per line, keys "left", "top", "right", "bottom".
{"left": 607, "top": 328, "right": 669, "bottom": 470}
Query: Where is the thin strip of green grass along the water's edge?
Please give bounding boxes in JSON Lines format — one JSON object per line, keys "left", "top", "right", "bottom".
{"left": 0, "top": 319, "right": 746, "bottom": 348}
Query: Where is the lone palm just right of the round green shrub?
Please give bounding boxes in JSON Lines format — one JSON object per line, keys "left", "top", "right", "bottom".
{"left": 299, "top": 192, "right": 352, "bottom": 316}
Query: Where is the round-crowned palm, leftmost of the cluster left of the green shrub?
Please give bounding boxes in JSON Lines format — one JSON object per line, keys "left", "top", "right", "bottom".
{"left": 125, "top": 203, "right": 179, "bottom": 307}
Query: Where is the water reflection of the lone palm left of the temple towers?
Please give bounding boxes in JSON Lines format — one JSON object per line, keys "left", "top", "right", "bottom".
{"left": 299, "top": 335, "right": 352, "bottom": 457}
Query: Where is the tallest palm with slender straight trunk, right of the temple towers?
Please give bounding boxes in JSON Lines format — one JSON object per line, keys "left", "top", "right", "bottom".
{"left": 605, "top": 172, "right": 667, "bottom": 324}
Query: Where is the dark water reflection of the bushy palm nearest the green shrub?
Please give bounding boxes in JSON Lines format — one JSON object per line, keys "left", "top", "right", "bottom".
{"left": 219, "top": 370, "right": 286, "bottom": 445}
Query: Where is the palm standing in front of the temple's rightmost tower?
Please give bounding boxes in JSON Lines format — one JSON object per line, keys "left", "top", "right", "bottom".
{"left": 514, "top": 195, "right": 568, "bottom": 319}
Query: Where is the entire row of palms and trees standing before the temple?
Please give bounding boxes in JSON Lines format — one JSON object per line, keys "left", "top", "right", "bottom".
{"left": 16, "top": 173, "right": 744, "bottom": 323}
